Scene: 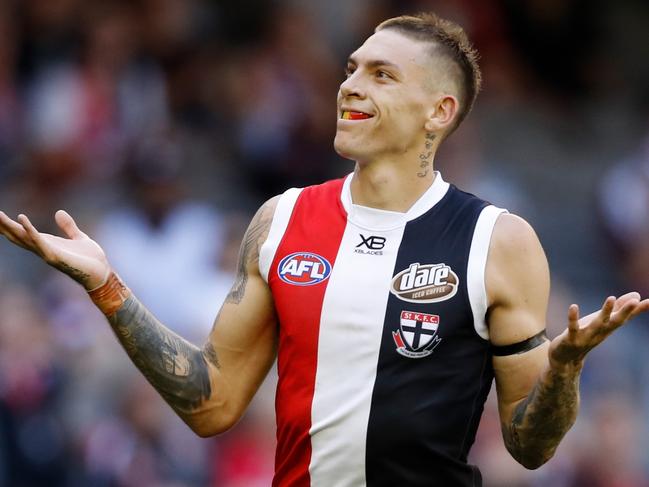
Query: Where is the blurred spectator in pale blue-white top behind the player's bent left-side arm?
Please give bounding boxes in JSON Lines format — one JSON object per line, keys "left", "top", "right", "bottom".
{"left": 97, "top": 132, "right": 232, "bottom": 340}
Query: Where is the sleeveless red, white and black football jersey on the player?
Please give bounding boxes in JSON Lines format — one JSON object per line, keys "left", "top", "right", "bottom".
{"left": 259, "top": 173, "right": 504, "bottom": 487}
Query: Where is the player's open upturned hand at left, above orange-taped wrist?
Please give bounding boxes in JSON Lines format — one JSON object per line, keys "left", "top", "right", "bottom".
{"left": 0, "top": 210, "right": 110, "bottom": 290}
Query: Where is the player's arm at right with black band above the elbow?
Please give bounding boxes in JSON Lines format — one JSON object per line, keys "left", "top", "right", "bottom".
{"left": 486, "top": 215, "right": 649, "bottom": 468}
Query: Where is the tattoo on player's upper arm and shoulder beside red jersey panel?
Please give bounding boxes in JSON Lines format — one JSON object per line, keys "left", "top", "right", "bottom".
{"left": 225, "top": 200, "right": 275, "bottom": 304}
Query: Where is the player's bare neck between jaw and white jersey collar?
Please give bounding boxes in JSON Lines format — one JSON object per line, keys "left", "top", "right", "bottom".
{"left": 351, "top": 155, "right": 435, "bottom": 213}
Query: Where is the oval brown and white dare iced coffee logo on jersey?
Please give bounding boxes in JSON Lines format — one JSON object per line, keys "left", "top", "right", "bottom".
{"left": 390, "top": 262, "right": 459, "bottom": 303}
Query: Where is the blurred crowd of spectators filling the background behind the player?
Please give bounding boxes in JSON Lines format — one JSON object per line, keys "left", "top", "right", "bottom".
{"left": 0, "top": 0, "right": 649, "bottom": 487}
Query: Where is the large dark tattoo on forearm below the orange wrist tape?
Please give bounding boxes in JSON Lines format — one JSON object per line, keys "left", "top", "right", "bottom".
{"left": 108, "top": 295, "right": 219, "bottom": 415}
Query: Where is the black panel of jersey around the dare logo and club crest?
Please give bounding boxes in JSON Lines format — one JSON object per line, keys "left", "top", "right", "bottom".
{"left": 366, "top": 185, "right": 493, "bottom": 487}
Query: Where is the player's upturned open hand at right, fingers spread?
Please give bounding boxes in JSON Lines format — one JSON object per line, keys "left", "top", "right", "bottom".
{"left": 549, "top": 292, "right": 649, "bottom": 368}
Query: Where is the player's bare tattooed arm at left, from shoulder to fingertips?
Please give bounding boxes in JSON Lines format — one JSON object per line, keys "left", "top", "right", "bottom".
{"left": 0, "top": 199, "right": 276, "bottom": 436}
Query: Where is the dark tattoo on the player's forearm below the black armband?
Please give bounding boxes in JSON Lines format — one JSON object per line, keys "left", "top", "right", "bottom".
{"left": 502, "top": 370, "right": 579, "bottom": 468}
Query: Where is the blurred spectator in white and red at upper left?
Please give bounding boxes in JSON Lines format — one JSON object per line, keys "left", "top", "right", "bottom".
{"left": 27, "top": 1, "right": 168, "bottom": 198}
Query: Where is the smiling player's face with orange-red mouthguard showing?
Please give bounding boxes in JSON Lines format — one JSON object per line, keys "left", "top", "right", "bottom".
{"left": 334, "top": 30, "right": 436, "bottom": 162}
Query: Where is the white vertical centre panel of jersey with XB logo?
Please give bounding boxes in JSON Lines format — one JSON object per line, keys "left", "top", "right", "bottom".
{"left": 309, "top": 219, "right": 405, "bottom": 487}
